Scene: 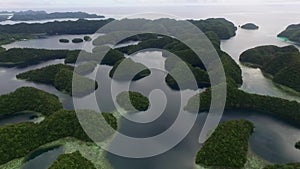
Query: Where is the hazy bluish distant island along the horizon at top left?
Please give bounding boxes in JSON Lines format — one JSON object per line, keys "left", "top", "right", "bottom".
{"left": 2, "top": 10, "right": 105, "bottom": 21}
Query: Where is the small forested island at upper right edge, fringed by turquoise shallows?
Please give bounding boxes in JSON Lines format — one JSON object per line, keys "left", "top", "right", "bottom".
{"left": 277, "top": 24, "right": 300, "bottom": 43}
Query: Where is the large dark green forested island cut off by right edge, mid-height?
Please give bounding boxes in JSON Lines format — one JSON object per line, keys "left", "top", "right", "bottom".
{"left": 240, "top": 46, "right": 300, "bottom": 92}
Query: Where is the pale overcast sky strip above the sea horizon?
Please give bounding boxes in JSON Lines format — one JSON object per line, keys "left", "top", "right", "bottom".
{"left": 0, "top": 0, "right": 300, "bottom": 10}
